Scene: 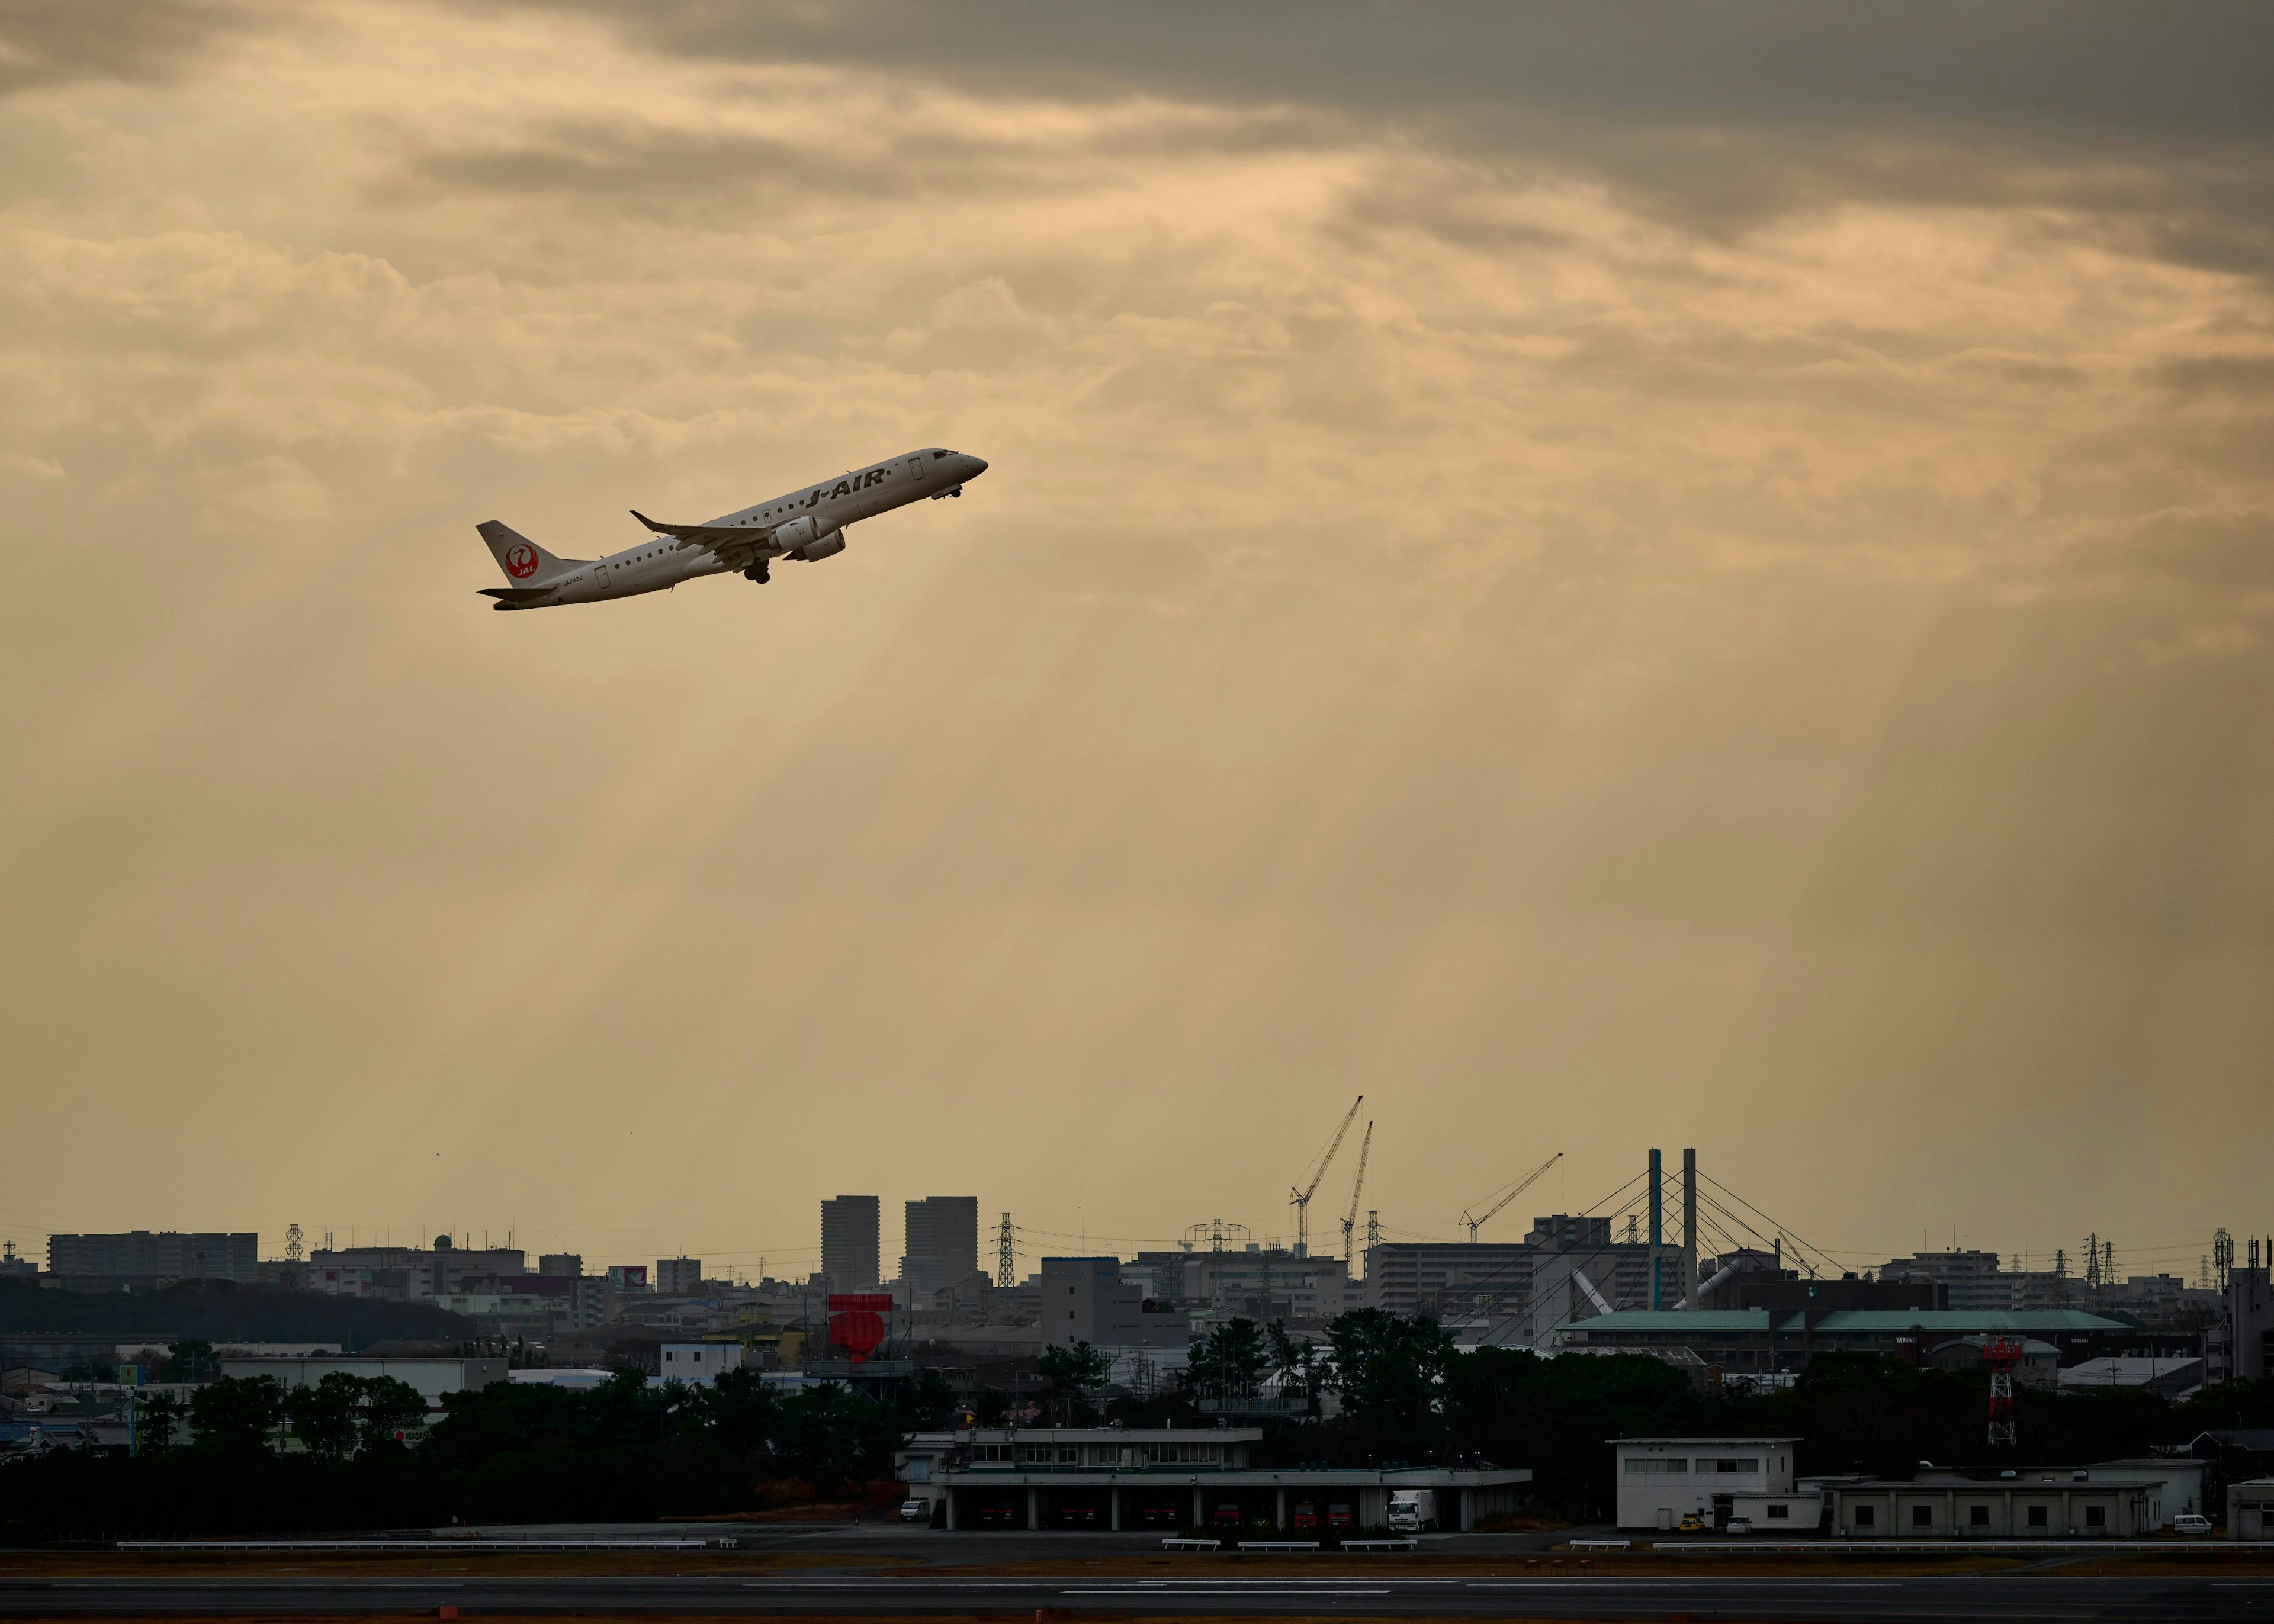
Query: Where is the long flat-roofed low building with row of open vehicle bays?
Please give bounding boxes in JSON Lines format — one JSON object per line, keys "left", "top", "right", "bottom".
{"left": 894, "top": 1426, "right": 1533, "bottom": 1533}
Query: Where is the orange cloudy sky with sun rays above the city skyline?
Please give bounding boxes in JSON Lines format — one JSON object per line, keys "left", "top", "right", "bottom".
{"left": 0, "top": 0, "right": 2274, "bottom": 1274}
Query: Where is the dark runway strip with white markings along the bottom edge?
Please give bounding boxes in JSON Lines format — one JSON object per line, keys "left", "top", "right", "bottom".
{"left": 0, "top": 1574, "right": 2274, "bottom": 1624}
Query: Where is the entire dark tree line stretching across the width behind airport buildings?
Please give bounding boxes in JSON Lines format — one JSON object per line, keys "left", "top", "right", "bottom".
{"left": 0, "top": 1310, "right": 2274, "bottom": 1540}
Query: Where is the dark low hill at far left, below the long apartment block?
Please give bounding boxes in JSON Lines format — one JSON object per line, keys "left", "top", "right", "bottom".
{"left": 0, "top": 1281, "right": 476, "bottom": 1351}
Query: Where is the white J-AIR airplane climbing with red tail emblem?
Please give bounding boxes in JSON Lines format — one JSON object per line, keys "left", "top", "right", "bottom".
{"left": 476, "top": 446, "right": 987, "bottom": 610}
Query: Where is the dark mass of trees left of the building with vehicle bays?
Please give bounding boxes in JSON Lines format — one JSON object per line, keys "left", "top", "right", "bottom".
{"left": 0, "top": 1372, "right": 953, "bottom": 1542}
